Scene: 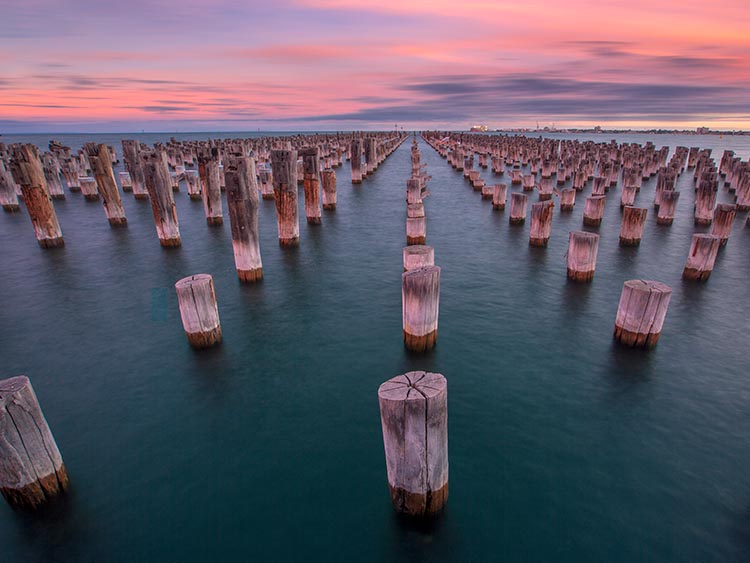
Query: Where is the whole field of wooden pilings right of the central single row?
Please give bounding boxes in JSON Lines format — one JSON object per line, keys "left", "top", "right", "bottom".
{"left": 422, "top": 132, "right": 750, "bottom": 347}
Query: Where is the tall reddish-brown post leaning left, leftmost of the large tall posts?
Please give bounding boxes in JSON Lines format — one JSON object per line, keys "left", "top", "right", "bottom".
{"left": 10, "top": 144, "right": 65, "bottom": 248}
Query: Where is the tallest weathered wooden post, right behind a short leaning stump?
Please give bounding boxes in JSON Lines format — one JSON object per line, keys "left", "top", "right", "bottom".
{"left": 224, "top": 156, "right": 263, "bottom": 282}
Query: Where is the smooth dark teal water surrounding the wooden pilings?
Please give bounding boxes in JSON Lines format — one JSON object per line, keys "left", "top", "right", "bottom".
{"left": 0, "top": 134, "right": 750, "bottom": 562}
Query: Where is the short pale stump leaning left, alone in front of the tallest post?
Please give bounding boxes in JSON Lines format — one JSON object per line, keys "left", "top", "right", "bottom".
{"left": 174, "top": 274, "right": 221, "bottom": 348}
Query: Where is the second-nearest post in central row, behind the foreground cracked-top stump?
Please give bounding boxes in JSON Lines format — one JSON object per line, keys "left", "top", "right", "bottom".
{"left": 401, "top": 266, "right": 440, "bottom": 352}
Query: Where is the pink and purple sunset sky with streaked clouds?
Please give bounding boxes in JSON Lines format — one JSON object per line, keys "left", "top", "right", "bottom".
{"left": 0, "top": 0, "right": 750, "bottom": 133}
